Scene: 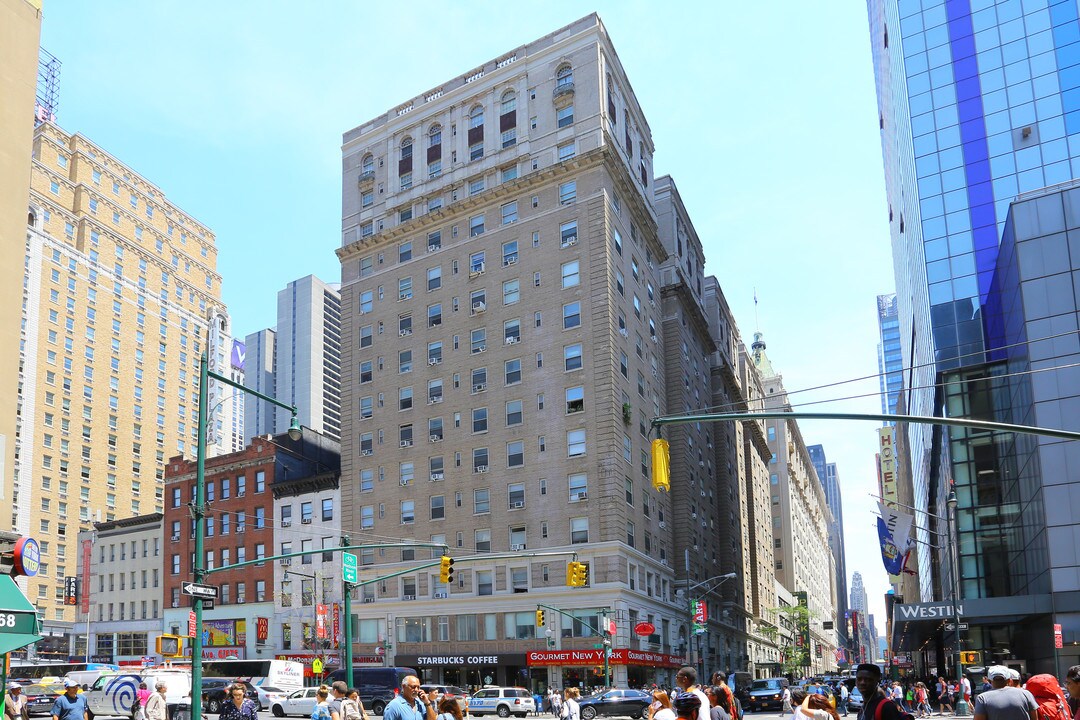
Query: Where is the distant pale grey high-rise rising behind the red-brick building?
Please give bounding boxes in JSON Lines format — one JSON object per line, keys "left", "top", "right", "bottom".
{"left": 245, "top": 275, "right": 341, "bottom": 439}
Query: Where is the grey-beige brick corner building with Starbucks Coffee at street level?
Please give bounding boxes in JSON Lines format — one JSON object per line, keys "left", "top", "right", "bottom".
{"left": 339, "top": 15, "right": 685, "bottom": 689}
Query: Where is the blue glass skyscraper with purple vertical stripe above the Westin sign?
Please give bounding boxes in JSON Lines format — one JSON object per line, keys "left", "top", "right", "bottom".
{"left": 867, "top": 0, "right": 1080, "bottom": 671}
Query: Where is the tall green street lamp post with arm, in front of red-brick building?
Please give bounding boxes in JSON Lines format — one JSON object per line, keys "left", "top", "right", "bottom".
{"left": 191, "top": 351, "right": 302, "bottom": 720}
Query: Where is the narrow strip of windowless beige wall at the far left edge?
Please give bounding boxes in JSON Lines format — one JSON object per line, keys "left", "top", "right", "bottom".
{"left": 0, "top": 0, "right": 41, "bottom": 518}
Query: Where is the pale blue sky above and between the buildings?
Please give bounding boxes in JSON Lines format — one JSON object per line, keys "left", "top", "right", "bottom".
{"left": 42, "top": 0, "right": 894, "bottom": 631}
